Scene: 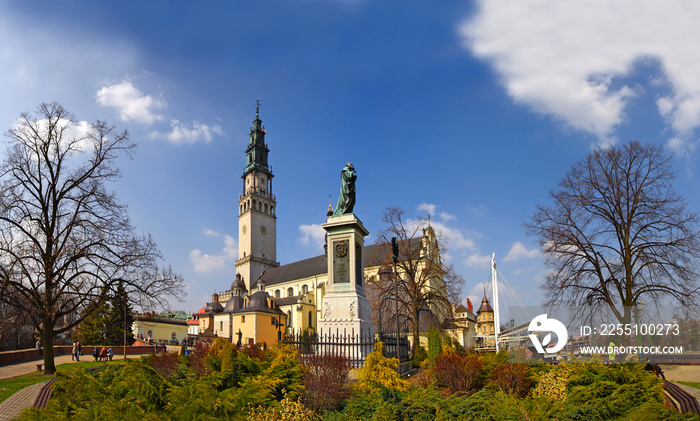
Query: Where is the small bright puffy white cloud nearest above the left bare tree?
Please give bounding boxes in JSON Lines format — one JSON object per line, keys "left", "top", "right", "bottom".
{"left": 96, "top": 80, "right": 166, "bottom": 126}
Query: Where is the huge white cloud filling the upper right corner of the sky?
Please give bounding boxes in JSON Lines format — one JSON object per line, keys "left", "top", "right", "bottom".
{"left": 459, "top": 0, "right": 700, "bottom": 151}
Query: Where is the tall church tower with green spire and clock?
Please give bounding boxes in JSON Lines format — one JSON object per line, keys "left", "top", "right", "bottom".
{"left": 236, "top": 102, "right": 279, "bottom": 291}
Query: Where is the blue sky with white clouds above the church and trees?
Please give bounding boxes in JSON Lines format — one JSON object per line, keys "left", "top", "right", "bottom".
{"left": 0, "top": 0, "right": 700, "bottom": 312}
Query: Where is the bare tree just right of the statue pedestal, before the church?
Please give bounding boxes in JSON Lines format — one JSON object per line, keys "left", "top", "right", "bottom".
{"left": 367, "top": 207, "right": 464, "bottom": 350}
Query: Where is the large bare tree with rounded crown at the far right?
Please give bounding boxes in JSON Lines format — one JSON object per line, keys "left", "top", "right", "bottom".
{"left": 525, "top": 142, "right": 700, "bottom": 324}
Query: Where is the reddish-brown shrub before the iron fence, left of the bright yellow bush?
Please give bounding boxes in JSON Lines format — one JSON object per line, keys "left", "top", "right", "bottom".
{"left": 301, "top": 354, "right": 350, "bottom": 412}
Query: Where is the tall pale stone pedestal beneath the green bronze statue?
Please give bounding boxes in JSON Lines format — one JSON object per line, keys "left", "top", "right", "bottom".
{"left": 318, "top": 214, "right": 374, "bottom": 338}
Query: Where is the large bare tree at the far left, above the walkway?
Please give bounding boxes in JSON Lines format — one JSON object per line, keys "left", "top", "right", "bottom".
{"left": 0, "top": 103, "right": 182, "bottom": 374}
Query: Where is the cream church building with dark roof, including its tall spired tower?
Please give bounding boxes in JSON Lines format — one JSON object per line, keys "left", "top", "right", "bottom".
{"left": 199, "top": 107, "right": 456, "bottom": 345}
